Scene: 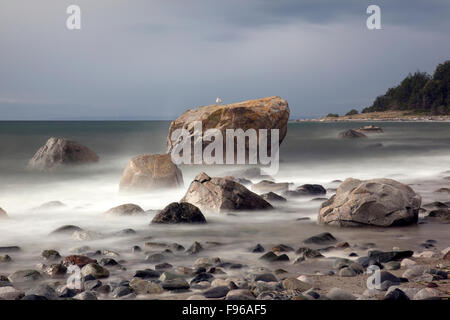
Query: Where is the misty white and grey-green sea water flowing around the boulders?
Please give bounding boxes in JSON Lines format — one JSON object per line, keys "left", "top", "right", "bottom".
{"left": 0, "top": 121, "right": 450, "bottom": 290}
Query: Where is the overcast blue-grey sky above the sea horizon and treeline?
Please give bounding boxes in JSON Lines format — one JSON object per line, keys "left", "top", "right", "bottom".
{"left": 0, "top": 0, "right": 450, "bottom": 120}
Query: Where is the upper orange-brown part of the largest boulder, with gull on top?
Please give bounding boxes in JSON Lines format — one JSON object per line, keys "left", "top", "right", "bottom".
{"left": 167, "top": 97, "right": 290, "bottom": 159}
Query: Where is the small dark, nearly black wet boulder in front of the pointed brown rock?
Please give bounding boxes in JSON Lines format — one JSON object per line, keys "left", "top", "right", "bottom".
{"left": 152, "top": 202, "right": 206, "bottom": 223}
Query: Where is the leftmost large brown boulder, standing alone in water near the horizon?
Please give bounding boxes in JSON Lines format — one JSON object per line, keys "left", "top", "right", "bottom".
{"left": 28, "top": 137, "right": 99, "bottom": 171}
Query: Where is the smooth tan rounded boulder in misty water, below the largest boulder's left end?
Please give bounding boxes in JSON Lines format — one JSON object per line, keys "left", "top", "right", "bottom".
{"left": 120, "top": 154, "right": 183, "bottom": 191}
